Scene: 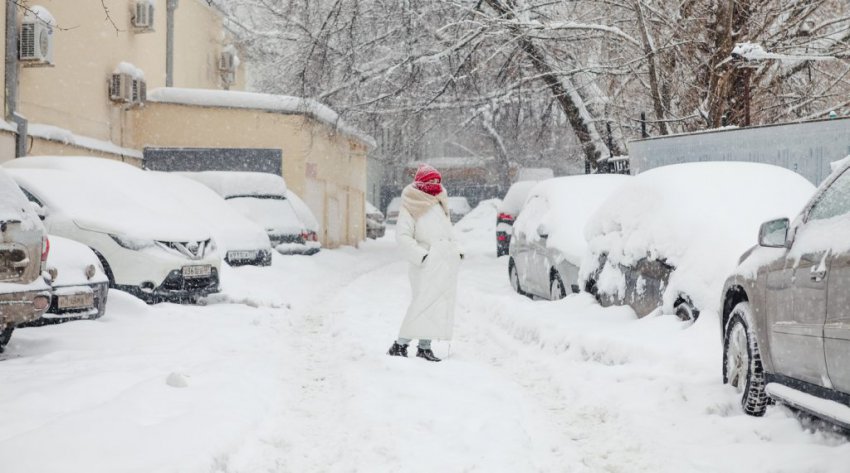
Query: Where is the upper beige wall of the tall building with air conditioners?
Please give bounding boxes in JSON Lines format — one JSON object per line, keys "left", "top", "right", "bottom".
{"left": 15, "top": 0, "right": 245, "bottom": 147}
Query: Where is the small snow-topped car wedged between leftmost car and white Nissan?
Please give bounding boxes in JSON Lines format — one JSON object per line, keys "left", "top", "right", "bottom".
{"left": 42, "top": 235, "right": 109, "bottom": 320}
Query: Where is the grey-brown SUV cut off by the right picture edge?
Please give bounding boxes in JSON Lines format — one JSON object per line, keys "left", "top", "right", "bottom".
{"left": 720, "top": 158, "right": 850, "bottom": 428}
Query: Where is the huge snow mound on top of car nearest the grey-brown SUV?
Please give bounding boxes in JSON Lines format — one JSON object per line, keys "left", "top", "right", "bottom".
{"left": 586, "top": 162, "right": 815, "bottom": 314}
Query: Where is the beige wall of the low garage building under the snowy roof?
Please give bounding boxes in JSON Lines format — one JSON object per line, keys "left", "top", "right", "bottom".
{"left": 125, "top": 103, "right": 367, "bottom": 248}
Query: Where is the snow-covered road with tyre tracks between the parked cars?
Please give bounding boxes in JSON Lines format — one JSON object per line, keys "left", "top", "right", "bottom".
{"left": 0, "top": 208, "right": 850, "bottom": 473}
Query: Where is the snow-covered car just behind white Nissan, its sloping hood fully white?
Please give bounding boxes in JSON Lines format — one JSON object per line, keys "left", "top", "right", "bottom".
{"left": 147, "top": 171, "right": 272, "bottom": 266}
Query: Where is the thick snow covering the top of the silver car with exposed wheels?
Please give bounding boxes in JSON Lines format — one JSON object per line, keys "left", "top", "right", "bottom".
{"left": 514, "top": 174, "right": 631, "bottom": 266}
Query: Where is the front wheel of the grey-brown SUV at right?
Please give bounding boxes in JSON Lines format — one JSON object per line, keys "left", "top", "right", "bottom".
{"left": 723, "top": 302, "right": 768, "bottom": 416}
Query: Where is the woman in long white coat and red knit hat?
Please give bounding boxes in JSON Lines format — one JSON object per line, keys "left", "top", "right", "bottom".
{"left": 388, "top": 165, "right": 463, "bottom": 361}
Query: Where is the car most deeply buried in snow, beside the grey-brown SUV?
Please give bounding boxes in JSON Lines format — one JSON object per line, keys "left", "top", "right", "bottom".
{"left": 581, "top": 162, "right": 814, "bottom": 320}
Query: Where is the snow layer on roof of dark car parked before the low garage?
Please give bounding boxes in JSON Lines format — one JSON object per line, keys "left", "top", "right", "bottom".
{"left": 180, "top": 171, "right": 286, "bottom": 199}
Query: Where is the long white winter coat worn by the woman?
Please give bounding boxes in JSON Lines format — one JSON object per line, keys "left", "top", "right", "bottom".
{"left": 396, "top": 186, "right": 460, "bottom": 340}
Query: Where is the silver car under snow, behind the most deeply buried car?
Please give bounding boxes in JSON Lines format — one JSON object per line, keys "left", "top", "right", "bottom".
{"left": 508, "top": 174, "right": 630, "bottom": 300}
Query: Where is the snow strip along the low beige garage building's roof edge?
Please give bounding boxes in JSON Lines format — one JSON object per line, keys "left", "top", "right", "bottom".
{"left": 147, "top": 87, "right": 376, "bottom": 148}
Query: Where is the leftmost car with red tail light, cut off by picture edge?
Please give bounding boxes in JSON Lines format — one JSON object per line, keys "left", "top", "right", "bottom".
{"left": 0, "top": 170, "right": 50, "bottom": 353}
